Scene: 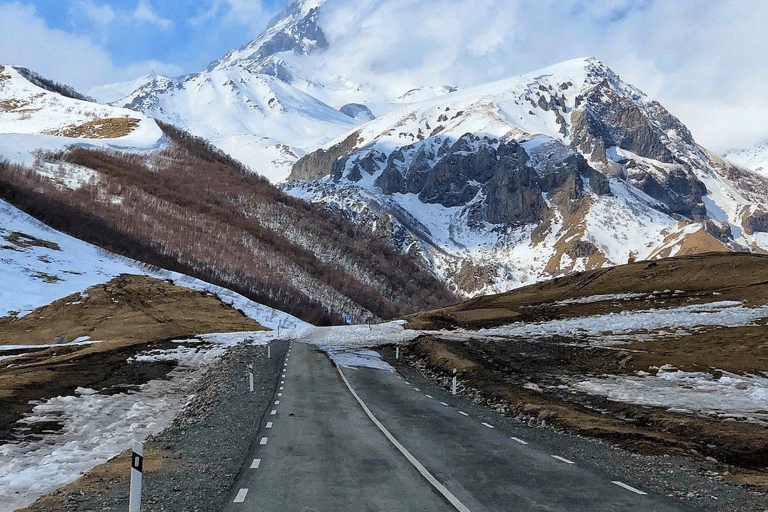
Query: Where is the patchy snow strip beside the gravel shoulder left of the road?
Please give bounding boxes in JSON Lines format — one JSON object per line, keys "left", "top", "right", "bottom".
{"left": 0, "top": 333, "right": 260, "bottom": 511}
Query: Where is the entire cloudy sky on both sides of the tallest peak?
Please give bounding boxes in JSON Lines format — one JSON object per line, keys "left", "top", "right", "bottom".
{"left": 0, "top": 0, "right": 768, "bottom": 151}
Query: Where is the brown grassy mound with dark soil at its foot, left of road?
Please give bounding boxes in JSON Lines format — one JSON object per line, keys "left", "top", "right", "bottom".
{"left": 0, "top": 275, "right": 264, "bottom": 440}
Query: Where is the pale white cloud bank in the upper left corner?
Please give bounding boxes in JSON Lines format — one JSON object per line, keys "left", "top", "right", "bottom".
{"left": 0, "top": 2, "right": 181, "bottom": 91}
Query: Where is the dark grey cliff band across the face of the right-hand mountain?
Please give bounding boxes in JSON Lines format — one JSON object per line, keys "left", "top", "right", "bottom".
{"left": 291, "top": 134, "right": 610, "bottom": 226}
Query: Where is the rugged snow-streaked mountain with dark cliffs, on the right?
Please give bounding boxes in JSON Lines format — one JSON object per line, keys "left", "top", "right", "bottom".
{"left": 284, "top": 58, "right": 768, "bottom": 295}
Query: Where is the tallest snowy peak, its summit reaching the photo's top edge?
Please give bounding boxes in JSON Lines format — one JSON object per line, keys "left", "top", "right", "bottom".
{"left": 109, "top": 0, "right": 366, "bottom": 182}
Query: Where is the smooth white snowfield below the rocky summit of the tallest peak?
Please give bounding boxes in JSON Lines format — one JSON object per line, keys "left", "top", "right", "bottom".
{"left": 113, "top": 66, "right": 358, "bottom": 181}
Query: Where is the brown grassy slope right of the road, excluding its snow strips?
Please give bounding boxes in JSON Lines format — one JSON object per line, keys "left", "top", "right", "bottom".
{"left": 409, "top": 253, "right": 768, "bottom": 488}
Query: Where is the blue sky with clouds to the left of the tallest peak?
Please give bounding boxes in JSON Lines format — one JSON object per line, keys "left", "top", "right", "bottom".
{"left": 0, "top": 0, "right": 288, "bottom": 89}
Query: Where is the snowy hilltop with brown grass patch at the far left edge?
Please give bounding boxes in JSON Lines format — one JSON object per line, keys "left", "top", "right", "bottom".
{"left": 0, "top": 65, "right": 164, "bottom": 164}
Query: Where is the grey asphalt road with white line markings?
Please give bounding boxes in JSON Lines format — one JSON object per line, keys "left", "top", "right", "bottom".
{"left": 223, "top": 343, "right": 689, "bottom": 512}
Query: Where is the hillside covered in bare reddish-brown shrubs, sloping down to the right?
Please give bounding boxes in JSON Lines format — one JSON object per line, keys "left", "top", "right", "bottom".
{"left": 0, "top": 125, "right": 455, "bottom": 323}
